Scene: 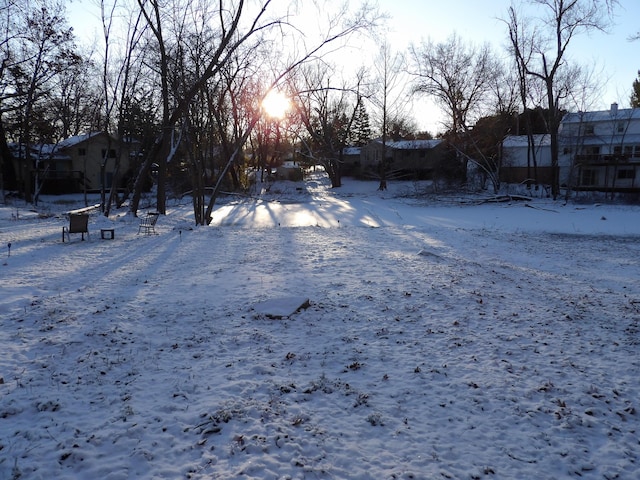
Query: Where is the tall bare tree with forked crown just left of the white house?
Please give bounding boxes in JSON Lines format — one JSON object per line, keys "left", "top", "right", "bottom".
{"left": 507, "top": 0, "right": 617, "bottom": 199}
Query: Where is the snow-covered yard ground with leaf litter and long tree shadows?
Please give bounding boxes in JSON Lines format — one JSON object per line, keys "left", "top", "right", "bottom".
{"left": 0, "top": 176, "right": 640, "bottom": 480}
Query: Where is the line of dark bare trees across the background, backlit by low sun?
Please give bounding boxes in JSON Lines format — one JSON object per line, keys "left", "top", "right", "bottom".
{"left": 0, "top": 0, "right": 637, "bottom": 224}
